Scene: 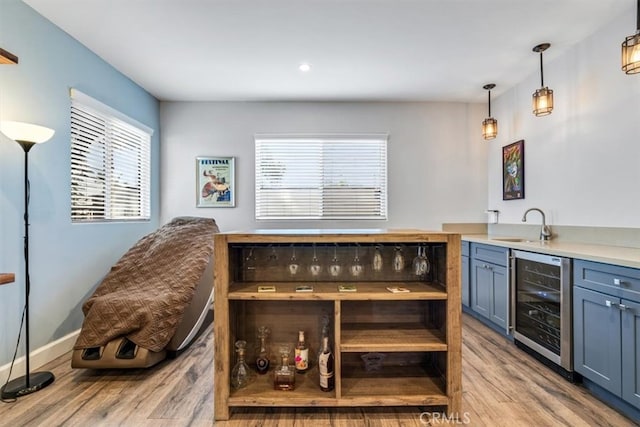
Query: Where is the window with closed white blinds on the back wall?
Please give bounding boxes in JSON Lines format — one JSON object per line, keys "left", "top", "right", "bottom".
{"left": 255, "top": 134, "right": 387, "bottom": 220}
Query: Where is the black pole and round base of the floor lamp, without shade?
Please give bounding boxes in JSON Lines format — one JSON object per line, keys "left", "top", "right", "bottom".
{"left": 0, "top": 141, "right": 55, "bottom": 399}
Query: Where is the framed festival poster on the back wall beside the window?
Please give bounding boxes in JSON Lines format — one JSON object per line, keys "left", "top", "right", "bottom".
{"left": 196, "top": 157, "right": 236, "bottom": 208}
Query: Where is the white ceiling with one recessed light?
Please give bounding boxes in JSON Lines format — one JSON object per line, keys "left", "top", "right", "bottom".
{"left": 23, "top": 0, "right": 636, "bottom": 102}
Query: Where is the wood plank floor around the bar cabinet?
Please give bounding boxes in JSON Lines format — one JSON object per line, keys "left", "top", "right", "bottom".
{"left": 0, "top": 315, "right": 636, "bottom": 427}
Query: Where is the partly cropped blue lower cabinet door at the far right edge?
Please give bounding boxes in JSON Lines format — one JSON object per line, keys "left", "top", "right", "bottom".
{"left": 621, "top": 300, "right": 640, "bottom": 408}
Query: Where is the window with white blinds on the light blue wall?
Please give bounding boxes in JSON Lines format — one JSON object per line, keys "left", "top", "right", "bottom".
{"left": 71, "top": 89, "right": 153, "bottom": 222}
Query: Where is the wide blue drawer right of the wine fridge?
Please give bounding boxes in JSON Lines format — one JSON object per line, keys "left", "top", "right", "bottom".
{"left": 573, "top": 259, "right": 640, "bottom": 301}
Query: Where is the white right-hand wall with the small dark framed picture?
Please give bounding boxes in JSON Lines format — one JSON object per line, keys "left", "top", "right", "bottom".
{"left": 488, "top": 9, "right": 640, "bottom": 228}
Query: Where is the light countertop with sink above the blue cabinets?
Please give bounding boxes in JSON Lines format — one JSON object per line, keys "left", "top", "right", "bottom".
{"left": 462, "top": 234, "right": 640, "bottom": 268}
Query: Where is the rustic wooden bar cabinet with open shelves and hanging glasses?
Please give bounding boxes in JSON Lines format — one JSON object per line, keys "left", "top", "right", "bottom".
{"left": 214, "top": 230, "right": 462, "bottom": 420}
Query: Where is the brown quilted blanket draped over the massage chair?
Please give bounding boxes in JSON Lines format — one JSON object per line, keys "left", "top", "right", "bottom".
{"left": 74, "top": 217, "right": 219, "bottom": 351}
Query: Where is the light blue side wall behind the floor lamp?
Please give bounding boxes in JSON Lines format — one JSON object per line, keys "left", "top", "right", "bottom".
{"left": 0, "top": 0, "right": 160, "bottom": 366}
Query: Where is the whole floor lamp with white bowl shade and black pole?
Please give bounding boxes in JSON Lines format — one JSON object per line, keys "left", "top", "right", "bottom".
{"left": 0, "top": 121, "right": 55, "bottom": 399}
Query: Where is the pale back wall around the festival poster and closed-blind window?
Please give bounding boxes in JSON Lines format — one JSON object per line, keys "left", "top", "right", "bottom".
{"left": 160, "top": 102, "right": 487, "bottom": 231}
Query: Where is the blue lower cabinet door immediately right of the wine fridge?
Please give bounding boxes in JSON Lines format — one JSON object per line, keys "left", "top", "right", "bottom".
{"left": 573, "top": 286, "right": 622, "bottom": 396}
